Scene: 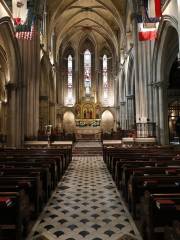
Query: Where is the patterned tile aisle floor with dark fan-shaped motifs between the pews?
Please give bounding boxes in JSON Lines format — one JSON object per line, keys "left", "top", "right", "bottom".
{"left": 28, "top": 156, "right": 141, "bottom": 240}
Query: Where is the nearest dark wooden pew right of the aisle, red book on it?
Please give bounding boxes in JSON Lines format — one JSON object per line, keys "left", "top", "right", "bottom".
{"left": 142, "top": 191, "right": 180, "bottom": 240}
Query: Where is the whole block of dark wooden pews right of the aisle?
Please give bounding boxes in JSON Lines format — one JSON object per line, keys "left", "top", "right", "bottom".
{"left": 103, "top": 145, "right": 180, "bottom": 240}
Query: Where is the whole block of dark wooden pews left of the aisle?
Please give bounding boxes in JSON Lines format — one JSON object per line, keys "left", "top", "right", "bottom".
{"left": 0, "top": 146, "right": 72, "bottom": 240}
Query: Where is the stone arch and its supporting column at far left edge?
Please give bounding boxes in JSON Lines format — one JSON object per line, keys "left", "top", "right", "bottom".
{"left": 0, "top": 17, "right": 21, "bottom": 146}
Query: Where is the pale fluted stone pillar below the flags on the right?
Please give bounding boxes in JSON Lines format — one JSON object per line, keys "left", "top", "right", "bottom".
{"left": 133, "top": 14, "right": 154, "bottom": 125}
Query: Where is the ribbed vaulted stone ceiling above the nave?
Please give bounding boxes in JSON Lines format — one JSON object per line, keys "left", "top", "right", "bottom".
{"left": 47, "top": 0, "right": 127, "bottom": 57}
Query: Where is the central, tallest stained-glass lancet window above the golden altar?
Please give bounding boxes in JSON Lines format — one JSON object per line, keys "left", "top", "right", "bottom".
{"left": 84, "top": 49, "right": 91, "bottom": 96}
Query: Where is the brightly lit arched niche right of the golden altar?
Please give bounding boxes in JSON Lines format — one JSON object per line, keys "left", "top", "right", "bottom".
{"left": 101, "top": 110, "right": 114, "bottom": 133}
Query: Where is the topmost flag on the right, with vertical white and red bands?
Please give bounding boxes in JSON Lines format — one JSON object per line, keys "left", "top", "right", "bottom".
{"left": 148, "top": 0, "right": 162, "bottom": 18}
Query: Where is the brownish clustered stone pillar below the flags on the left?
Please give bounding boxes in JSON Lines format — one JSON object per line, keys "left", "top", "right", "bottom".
{"left": 18, "top": 31, "right": 40, "bottom": 139}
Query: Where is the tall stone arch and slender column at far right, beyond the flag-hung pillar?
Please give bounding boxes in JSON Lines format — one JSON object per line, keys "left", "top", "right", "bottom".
{"left": 152, "top": 16, "right": 179, "bottom": 144}
